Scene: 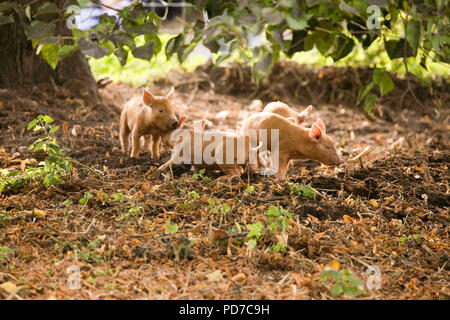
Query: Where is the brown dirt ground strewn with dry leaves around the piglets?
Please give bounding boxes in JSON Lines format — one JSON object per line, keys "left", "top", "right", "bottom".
{"left": 0, "top": 65, "right": 450, "bottom": 299}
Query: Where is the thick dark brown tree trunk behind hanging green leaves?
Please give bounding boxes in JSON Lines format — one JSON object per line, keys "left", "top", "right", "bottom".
{"left": 0, "top": 0, "right": 99, "bottom": 103}
